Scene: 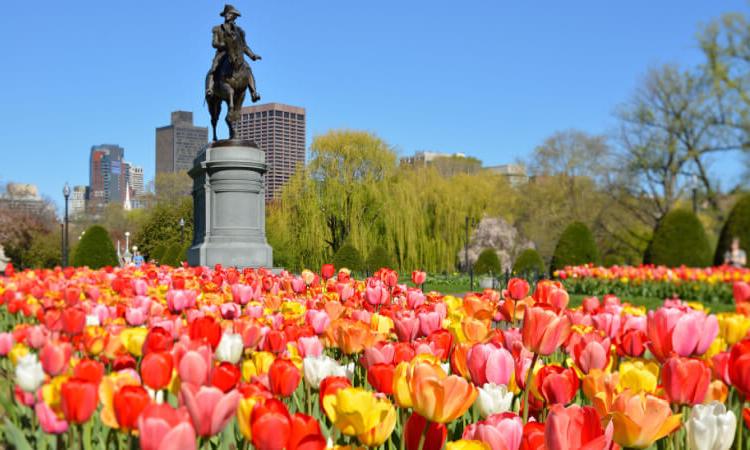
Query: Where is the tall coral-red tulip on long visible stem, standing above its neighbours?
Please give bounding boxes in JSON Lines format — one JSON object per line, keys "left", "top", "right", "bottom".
{"left": 521, "top": 306, "right": 570, "bottom": 356}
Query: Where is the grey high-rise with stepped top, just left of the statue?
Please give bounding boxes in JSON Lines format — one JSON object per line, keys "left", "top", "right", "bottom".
{"left": 156, "top": 111, "right": 208, "bottom": 173}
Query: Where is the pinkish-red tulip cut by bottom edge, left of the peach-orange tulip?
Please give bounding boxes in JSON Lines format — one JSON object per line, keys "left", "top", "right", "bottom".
{"left": 544, "top": 405, "right": 613, "bottom": 450}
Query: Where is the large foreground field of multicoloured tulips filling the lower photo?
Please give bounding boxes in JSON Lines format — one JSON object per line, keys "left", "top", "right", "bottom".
{"left": 0, "top": 265, "right": 750, "bottom": 450}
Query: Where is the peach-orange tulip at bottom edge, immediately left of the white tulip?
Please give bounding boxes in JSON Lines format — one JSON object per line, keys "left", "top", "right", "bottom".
{"left": 612, "top": 390, "right": 682, "bottom": 448}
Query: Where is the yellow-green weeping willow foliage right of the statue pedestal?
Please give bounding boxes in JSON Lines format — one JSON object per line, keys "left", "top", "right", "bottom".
{"left": 267, "top": 131, "right": 514, "bottom": 271}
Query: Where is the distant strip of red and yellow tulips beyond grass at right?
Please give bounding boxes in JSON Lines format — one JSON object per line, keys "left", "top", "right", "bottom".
{"left": 554, "top": 265, "right": 750, "bottom": 303}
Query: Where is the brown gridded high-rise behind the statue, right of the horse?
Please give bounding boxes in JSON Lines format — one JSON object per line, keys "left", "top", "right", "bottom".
{"left": 235, "top": 103, "right": 306, "bottom": 201}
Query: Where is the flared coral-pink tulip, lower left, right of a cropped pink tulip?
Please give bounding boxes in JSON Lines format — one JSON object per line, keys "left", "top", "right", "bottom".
{"left": 180, "top": 384, "right": 241, "bottom": 437}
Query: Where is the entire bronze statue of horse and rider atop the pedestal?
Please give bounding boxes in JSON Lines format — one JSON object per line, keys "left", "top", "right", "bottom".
{"left": 206, "top": 5, "right": 261, "bottom": 141}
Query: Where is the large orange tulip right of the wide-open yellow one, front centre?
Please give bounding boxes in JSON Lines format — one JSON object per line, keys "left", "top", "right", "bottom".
{"left": 408, "top": 362, "right": 477, "bottom": 423}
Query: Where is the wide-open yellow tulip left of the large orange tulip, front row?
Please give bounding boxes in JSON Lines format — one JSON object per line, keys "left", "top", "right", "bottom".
{"left": 323, "top": 387, "right": 393, "bottom": 436}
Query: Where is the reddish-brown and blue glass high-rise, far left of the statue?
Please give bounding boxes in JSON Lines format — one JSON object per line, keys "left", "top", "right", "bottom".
{"left": 89, "top": 144, "right": 129, "bottom": 208}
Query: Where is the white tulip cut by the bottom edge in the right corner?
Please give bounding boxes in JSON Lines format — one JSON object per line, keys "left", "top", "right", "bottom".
{"left": 685, "top": 401, "right": 737, "bottom": 450}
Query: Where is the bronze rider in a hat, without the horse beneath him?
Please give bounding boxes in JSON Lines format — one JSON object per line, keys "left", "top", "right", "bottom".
{"left": 206, "top": 5, "right": 261, "bottom": 103}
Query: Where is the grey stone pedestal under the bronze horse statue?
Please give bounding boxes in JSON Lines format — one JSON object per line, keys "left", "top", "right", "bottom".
{"left": 188, "top": 140, "right": 273, "bottom": 269}
